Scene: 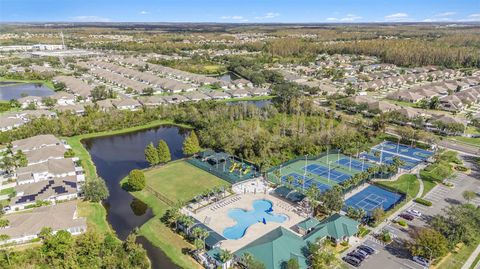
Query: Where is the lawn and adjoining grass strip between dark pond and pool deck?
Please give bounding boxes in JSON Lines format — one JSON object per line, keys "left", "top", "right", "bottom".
{"left": 121, "top": 160, "right": 229, "bottom": 268}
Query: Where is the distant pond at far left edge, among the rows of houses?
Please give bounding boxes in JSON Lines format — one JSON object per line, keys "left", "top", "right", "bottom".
{"left": 0, "top": 82, "right": 54, "bottom": 100}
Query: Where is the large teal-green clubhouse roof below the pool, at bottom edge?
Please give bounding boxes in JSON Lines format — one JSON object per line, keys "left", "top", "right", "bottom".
{"left": 235, "top": 227, "right": 308, "bottom": 269}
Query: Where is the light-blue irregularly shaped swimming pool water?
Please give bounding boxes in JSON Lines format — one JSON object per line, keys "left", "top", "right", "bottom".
{"left": 223, "top": 200, "right": 287, "bottom": 239}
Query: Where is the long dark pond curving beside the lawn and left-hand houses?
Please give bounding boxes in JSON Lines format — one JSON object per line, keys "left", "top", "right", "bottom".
{"left": 82, "top": 126, "right": 188, "bottom": 269}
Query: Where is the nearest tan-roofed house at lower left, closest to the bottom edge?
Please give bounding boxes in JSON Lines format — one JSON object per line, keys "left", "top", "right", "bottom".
{"left": 0, "top": 201, "right": 87, "bottom": 245}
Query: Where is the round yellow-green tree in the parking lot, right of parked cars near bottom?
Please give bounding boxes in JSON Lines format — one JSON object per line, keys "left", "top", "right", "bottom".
{"left": 408, "top": 228, "right": 448, "bottom": 260}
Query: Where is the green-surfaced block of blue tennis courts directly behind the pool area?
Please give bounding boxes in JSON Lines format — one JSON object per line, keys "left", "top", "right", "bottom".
{"left": 268, "top": 153, "right": 374, "bottom": 191}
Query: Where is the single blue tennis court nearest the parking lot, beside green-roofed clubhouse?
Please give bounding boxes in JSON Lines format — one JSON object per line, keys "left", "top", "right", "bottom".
{"left": 345, "top": 185, "right": 403, "bottom": 215}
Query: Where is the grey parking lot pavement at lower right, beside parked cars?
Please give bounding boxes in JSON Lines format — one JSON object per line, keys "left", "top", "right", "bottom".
{"left": 349, "top": 155, "right": 480, "bottom": 269}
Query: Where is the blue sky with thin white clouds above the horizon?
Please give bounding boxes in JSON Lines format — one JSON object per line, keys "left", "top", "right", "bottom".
{"left": 0, "top": 0, "right": 480, "bottom": 23}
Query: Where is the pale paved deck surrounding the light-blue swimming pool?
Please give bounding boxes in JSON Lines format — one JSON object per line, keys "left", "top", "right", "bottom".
{"left": 192, "top": 193, "right": 305, "bottom": 252}
